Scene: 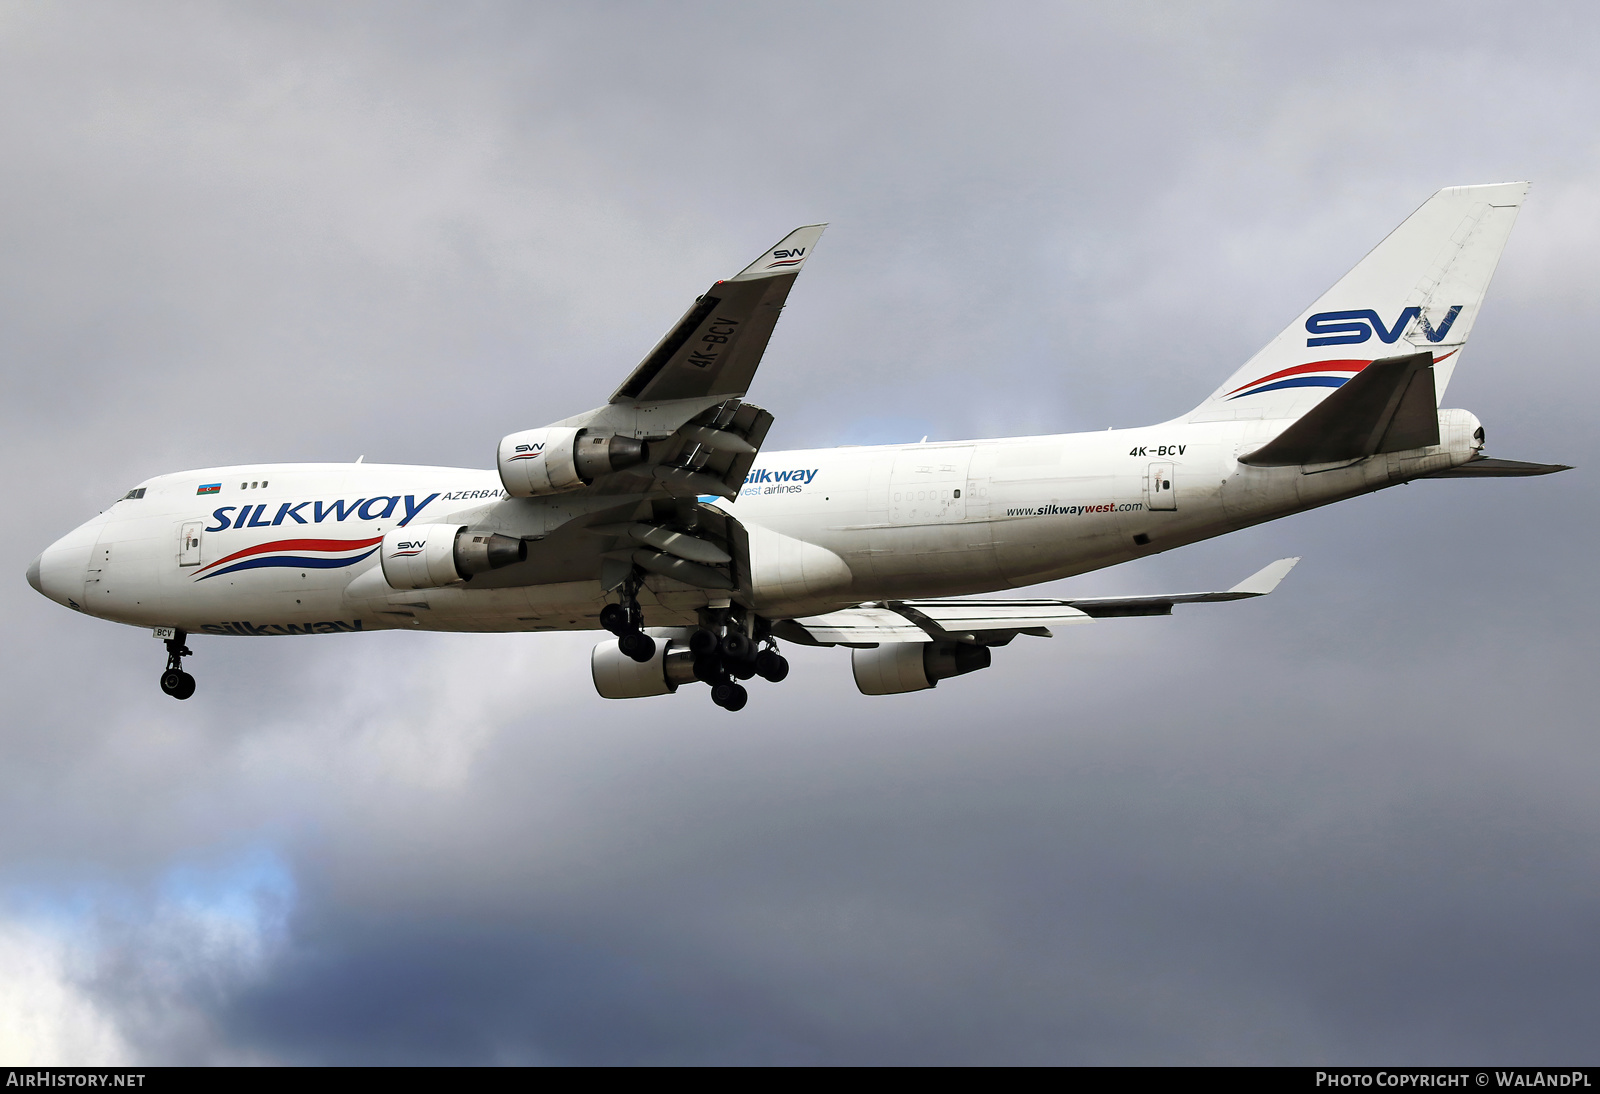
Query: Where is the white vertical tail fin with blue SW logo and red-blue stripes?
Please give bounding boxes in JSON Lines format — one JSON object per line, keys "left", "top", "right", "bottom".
{"left": 1186, "top": 182, "right": 1528, "bottom": 425}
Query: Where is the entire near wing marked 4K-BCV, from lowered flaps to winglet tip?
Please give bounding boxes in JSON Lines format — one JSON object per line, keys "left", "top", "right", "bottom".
{"left": 451, "top": 224, "right": 826, "bottom": 592}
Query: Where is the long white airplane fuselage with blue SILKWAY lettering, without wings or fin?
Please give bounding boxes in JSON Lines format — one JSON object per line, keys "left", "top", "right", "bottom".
{"left": 35, "top": 411, "right": 1477, "bottom": 635}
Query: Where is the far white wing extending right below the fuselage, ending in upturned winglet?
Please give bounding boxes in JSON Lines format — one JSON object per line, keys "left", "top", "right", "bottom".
{"left": 774, "top": 558, "right": 1299, "bottom": 646}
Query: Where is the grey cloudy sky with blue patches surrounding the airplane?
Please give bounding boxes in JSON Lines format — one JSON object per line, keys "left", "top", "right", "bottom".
{"left": 0, "top": 0, "right": 1600, "bottom": 1064}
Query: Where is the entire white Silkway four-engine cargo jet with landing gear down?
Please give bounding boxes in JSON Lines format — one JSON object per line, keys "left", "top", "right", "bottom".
{"left": 27, "top": 182, "right": 1565, "bottom": 710}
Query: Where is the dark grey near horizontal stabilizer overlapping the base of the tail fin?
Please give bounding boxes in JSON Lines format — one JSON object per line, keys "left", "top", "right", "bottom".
{"left": 1238, "top": 350, "right": 1438, "bottom": 467}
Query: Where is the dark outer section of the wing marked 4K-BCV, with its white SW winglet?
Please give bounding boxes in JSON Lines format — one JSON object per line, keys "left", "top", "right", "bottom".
{"left": 611, "top": 224, "right": 827, "bottom": 403}
